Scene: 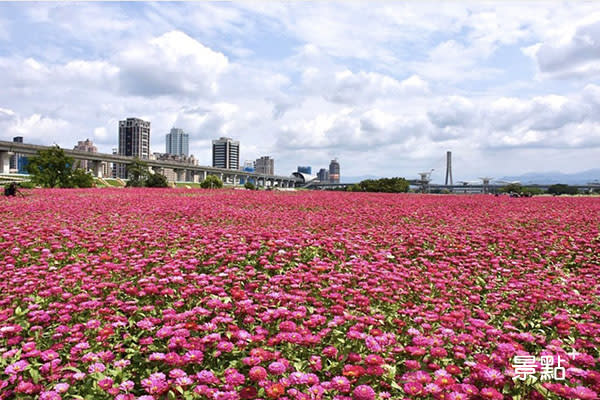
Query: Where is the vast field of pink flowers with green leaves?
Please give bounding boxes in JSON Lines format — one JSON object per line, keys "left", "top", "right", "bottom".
{"left": 0, "top": 189, "right": 600, "bottom": 400}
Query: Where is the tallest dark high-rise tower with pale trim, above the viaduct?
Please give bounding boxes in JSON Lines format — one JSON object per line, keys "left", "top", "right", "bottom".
{"left": 118, "top": 118, "right": 150, "bottom": 178}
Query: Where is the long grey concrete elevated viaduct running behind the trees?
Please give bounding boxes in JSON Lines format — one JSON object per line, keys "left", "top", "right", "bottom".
{"left": 0, "top": 141, "right": 298, "bottom": 188}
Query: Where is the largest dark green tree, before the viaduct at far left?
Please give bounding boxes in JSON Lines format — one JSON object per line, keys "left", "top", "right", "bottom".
{"left": 27, "top": 145, "right": 75, "bottom": 188}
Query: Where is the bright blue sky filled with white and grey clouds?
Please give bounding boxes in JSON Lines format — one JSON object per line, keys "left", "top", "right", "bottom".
{"left": 0, "top": 1, "right": 600, "bottom": 181}
